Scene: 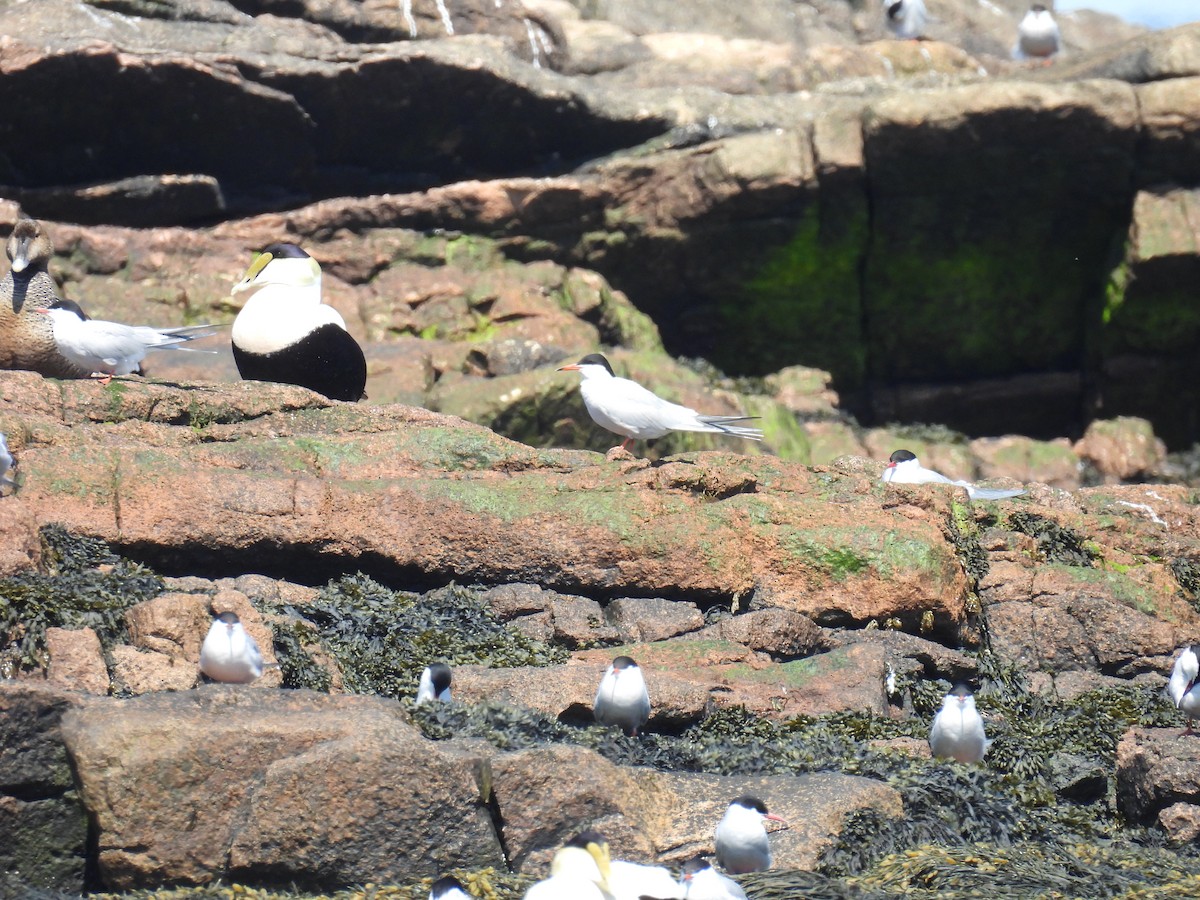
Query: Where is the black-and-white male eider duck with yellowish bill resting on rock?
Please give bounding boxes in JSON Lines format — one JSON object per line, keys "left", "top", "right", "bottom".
{"left": 233, "top": 244, "right": 367, "bottom": 401}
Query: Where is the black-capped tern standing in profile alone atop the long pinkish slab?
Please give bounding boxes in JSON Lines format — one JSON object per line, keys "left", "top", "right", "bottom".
{"left": 558, "top": 353, "right": 762, "bottom": 450}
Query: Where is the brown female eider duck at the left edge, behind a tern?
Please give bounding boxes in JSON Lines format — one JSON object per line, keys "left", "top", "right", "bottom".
{"left": 0, "top": 216, "right": 90, "bottom": 378}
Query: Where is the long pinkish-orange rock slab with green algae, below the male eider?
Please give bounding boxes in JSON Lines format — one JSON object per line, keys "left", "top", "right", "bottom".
{"left": 0, "top": 372, "right": 966, "bottom": 630}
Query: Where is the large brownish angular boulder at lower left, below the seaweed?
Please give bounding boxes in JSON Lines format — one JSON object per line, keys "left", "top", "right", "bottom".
{"left": 62, "top": 685, "right": 503, "bottom": 889}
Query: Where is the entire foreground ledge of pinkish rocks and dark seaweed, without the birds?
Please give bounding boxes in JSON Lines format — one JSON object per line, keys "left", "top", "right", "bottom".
{"left": 0, "top": 372, "right": 1200, "bottom": 898}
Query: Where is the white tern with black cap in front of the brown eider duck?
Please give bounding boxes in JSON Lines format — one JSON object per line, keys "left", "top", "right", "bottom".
{"left": 37, "top": 300, "right": 216, "bottom": 384}
